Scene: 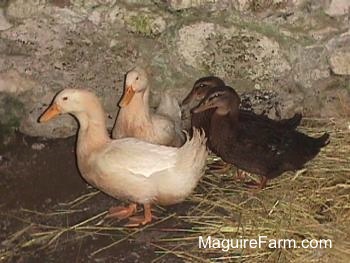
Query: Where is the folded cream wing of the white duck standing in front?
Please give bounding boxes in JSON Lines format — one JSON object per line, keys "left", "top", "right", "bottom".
{"left": 96, "top": 138, "right": 178, "bottom": 177}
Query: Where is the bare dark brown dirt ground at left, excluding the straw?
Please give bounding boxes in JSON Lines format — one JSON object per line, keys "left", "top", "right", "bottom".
{"left": 0, "top": 134, "right": 186, "bottom": 262}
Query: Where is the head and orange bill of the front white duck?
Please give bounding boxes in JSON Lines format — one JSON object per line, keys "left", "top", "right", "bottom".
{"left": 39, "top": 89, "right": 100, "bottom": 122}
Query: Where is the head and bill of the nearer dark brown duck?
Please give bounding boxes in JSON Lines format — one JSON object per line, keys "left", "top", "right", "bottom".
{"left": 191, "top": 86, "right": 240, "bottom": 115}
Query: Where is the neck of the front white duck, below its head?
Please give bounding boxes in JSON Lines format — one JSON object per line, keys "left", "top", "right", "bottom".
{"left": 75, "top": 109, "right": 111, "bottom": 159}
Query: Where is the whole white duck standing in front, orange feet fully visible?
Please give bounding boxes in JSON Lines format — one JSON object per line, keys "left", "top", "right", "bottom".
{"left": 39, "top": 89, "right": 207, "bottom": 226}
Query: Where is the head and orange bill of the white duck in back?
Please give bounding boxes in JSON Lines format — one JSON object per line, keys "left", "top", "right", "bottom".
{"left": 119, "top": 67, "right": 148, "bottom": 107}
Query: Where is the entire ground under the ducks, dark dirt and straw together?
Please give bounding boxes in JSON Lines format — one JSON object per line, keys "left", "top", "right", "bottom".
{"left": 0, "top": 121, "right": 350, "bottom": 263}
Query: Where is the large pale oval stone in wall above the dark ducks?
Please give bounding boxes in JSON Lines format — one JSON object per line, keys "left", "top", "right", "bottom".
{"left": 177, "top": 22, "right": 291, "bottom": 86}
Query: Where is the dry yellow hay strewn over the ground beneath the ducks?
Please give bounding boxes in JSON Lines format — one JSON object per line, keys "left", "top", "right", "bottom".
{"left": 0, "top": 120, "right": 350, "bottom": 262}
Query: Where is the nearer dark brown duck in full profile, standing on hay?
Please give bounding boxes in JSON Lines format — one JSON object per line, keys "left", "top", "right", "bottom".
{"left": 192, "top": 87, "right": 329, "bottom": 188}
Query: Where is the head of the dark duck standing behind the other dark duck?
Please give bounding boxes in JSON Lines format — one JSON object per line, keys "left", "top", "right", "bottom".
{"left": 182, "top": 76, "right": 225, "bottom": 106}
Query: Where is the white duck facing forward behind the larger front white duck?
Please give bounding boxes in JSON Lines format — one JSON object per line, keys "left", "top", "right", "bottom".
{"left": 112, "top": 67, "right": 185, "bottom": 147}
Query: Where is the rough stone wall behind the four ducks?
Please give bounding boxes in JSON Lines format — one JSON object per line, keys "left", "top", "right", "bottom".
{"left": 0, "top": 0, "right": 350, "bottom": 137}
